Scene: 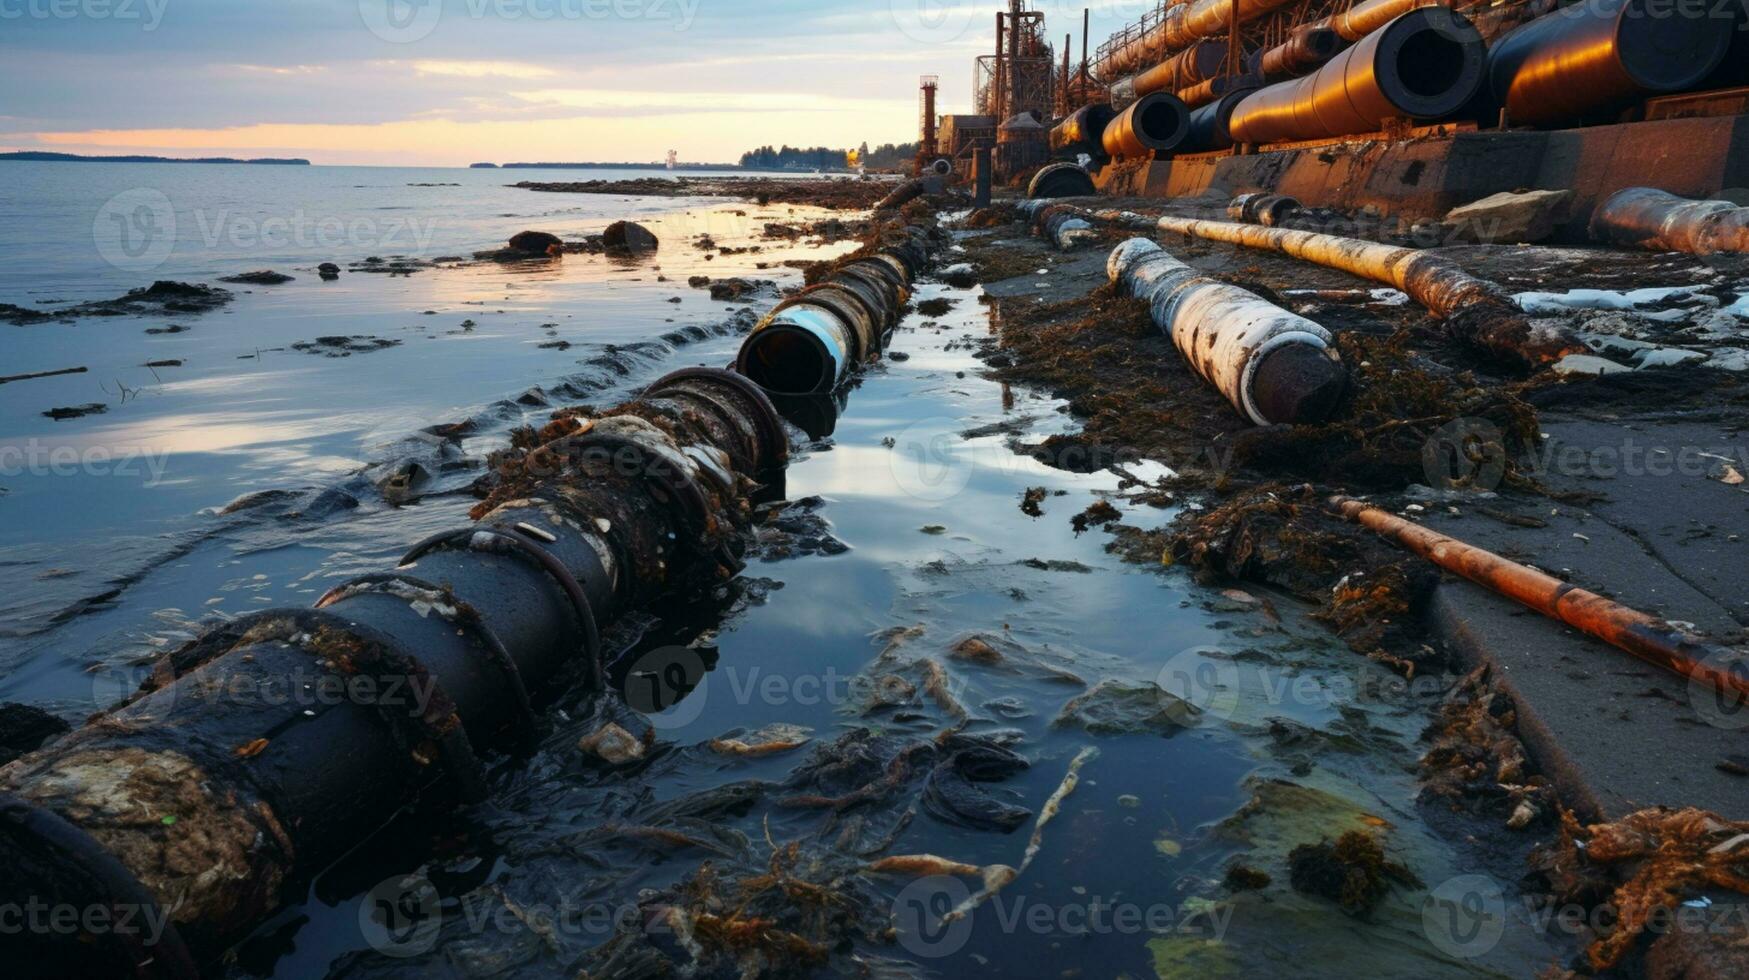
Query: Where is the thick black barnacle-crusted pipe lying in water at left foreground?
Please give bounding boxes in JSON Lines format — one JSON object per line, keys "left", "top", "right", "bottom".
{"left": 0, "top": 229, "right": 927, "bottom": 978}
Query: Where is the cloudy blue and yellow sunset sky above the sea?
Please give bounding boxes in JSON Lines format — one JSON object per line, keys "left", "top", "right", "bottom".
{"left": 0, "top": 0, "right": 1156, "bottom": 166}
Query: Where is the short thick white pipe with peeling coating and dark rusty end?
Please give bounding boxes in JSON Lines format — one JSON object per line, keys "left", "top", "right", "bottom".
{"left": 1105, "top": 238, "right": 1347, "bottom": 425}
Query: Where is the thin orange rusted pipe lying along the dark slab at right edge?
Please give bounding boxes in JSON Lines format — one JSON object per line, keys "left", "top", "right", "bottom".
{"left": 1331, "top": 497, "right": 1749, "bottom": 702}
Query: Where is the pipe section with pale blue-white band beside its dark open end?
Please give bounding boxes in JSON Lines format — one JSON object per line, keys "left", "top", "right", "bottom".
{"left": 736, "top": 229, "right": 929, "bottom": 396}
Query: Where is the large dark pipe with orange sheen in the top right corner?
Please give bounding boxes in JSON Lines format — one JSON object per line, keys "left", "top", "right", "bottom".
{"left": 1488, "top": 0, "right": 1735, "bottom": 126}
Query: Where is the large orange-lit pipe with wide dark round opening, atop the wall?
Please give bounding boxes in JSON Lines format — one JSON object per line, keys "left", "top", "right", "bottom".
{"left": 1230, "top": 7, "right": 1487, "bottom": 144}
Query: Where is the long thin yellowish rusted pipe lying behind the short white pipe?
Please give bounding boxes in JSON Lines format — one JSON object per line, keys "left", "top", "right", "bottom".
{"left": 1154, "top": 215, "right": 1586, "bottom": 368}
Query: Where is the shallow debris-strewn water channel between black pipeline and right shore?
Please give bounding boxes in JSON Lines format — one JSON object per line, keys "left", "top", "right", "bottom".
{"left": 195, "top": 271, "right": 1569, "bottom": 978}
